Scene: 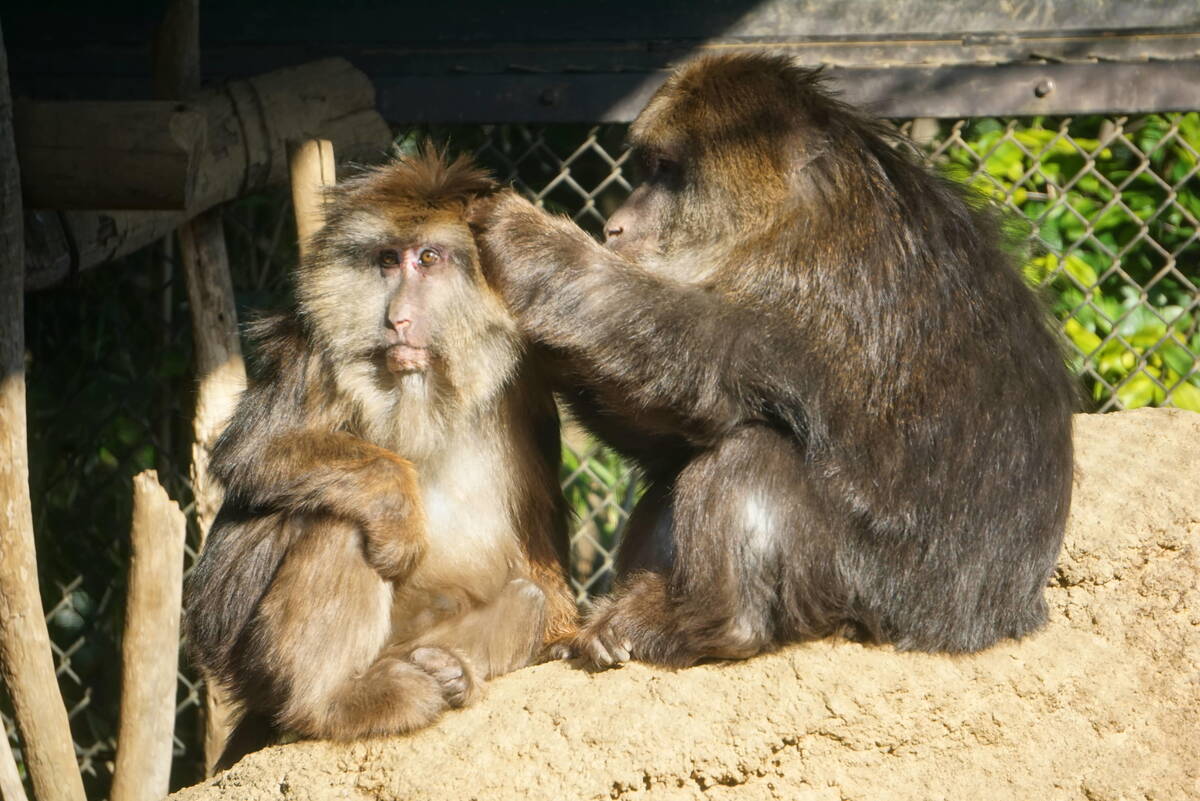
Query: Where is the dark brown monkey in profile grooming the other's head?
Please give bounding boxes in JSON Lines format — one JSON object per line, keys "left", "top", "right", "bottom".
{"left": 472, "top": 54, "right": 1076, "bottom": 669}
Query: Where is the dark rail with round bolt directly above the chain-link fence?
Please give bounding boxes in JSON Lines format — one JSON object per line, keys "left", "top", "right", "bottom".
{"left": 376, "top": 57, "right": 1200, "bottom": 125}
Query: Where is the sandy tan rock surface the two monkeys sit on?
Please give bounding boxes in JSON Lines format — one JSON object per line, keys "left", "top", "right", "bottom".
{"left": 173, "top": 410, "right": 1200, "bottom": 801}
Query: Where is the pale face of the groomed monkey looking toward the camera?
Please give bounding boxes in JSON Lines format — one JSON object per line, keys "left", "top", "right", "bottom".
{"left": 298, "top": 204, "right": 515, "bottom": 390}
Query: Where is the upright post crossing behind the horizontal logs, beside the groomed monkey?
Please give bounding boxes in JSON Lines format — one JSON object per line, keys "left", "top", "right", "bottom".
{"left": 154, "top": 0, "right": 246, "bottom": 776}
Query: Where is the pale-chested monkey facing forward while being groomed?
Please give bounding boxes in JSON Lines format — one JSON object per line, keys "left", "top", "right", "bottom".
{"left": 185, "top": 145, "right": 577, "bottom": 767}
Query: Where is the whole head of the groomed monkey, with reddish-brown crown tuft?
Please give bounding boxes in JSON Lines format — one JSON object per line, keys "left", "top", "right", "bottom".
{"left": 296, "top": 146, "right": 518, "bottom": 412}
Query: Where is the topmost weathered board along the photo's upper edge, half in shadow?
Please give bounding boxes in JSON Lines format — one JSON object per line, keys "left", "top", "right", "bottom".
{"left": 6, "top": 0, "right": 1200, "bottom": 50}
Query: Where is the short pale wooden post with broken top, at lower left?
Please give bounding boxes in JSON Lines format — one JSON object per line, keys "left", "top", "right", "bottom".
{"left": 109, "top": 470, "right": 187, "bottom": 801}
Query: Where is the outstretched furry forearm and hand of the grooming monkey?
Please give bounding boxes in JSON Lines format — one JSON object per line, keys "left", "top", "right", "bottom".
{"left": 478, "top": 193, "right": 803, "bottom": 438}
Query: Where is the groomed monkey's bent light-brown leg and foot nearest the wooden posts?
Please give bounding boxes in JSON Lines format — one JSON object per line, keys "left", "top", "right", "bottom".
{"left": 246, "top": 517, "right": 458, "bottom": 739}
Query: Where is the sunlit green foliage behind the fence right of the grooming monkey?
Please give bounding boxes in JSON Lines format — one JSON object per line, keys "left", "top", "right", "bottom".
{"left": 944, "top": 113, "right": 1200, "bottom": 411}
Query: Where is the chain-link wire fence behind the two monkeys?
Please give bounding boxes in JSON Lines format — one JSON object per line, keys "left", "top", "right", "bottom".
{"left": 0, "top": 113, "right": 1200, "bottom": 799}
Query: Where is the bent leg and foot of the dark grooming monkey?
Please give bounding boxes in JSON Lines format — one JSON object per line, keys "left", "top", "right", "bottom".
{"left": 576, "top": 426, "right": 835, "bottom": 668}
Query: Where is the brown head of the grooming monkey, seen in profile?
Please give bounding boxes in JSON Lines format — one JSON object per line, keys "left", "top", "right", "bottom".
{"left": 605, "top": 54, "right": 868, "bottom": 281}
